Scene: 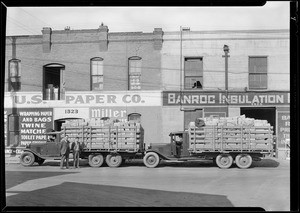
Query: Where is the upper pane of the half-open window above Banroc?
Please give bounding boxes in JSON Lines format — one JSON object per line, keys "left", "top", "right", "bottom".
{"left": 184, "top": 58, "right": 203, "bottom": 76}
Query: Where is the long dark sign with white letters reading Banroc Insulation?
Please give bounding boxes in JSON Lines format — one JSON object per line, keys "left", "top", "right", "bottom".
{"left": 163, "top": 91, "right": 290, "bottom": 106}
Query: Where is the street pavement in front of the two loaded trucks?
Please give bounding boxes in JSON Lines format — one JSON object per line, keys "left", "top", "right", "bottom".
{"left": 5, "top": 157, "right": 290, "bottom": 211}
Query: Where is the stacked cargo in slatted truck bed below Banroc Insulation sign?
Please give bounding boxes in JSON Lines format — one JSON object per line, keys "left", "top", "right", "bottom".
{"left": 188, "top": 115, "right": 273, "bottom": 152}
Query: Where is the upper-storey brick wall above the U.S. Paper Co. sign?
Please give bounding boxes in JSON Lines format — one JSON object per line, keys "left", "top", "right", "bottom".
{"left": 5, "top": 26, "right": 161, "bottom": 91}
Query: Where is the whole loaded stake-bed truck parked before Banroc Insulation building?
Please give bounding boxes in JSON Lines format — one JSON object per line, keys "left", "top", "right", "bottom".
{"left": 143, "top": 117, "right": 274, "bottom": 169}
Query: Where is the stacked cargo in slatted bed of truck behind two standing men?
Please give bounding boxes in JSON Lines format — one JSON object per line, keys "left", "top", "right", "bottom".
{"left": 62, "top": 119, "right": 144, "bottom": 152}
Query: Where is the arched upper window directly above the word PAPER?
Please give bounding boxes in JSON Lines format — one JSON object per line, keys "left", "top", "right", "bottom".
{"left": 91, "top": 58, "right": 103, "bottom": 91}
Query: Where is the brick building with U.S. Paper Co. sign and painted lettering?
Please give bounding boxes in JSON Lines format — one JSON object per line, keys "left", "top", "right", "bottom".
{"left": 4, "top": 26, "right": 162, "bottom": 151}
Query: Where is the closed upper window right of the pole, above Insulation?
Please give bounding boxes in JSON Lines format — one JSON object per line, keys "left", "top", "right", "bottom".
{"left": 249, "top": 56, "right": 268, "bottom": 89}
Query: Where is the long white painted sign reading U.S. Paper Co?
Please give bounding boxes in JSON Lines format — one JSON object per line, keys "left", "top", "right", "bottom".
{"left": 5, "top": 91, "right": 162, "bottom": 108}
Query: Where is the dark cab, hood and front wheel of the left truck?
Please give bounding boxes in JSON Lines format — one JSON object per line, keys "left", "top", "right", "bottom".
{"left": 20, "top": 131, "right": 61, "bottom": 166}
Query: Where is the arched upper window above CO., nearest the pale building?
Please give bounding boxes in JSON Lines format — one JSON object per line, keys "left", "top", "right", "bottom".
{"left": 129, "top": 56, "right": 142, "bottom": 90}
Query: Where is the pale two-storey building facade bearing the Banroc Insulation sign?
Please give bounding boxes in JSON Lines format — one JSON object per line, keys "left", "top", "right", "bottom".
{"left": 161, "top": 30, "right": 290, "bottom": 158}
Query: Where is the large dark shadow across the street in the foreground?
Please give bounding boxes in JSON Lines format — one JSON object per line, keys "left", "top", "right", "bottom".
{"left": 7, "top": 182, "right": 233, "bottom": 206}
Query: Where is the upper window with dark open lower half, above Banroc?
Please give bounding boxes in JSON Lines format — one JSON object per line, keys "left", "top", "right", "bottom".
{"left": 184, "top": 58, "right": 203, "bottom": 89}
